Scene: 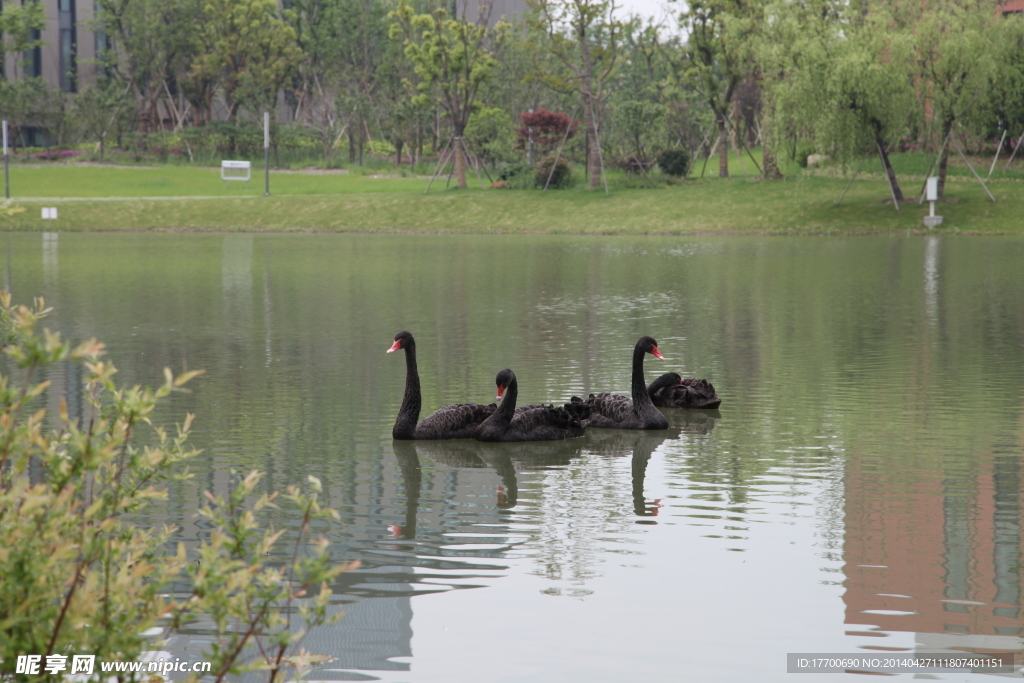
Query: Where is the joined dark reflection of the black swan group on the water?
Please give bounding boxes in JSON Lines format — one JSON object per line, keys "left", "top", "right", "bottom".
{"left": 389, "top": 410, "right": 721, "bottom": 540}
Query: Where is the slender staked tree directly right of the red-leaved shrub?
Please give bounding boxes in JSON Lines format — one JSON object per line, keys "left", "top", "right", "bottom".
{"left": 527, "top": 0, "right": 623, "bottom": 189}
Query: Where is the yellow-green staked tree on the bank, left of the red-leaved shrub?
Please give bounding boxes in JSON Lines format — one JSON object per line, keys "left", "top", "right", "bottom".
{"left": 389, "top": 0, "right": 508, "bottom": 188}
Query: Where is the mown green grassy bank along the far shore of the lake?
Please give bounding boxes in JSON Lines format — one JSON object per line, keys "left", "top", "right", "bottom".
{"left": 0, "top": 166, "right": 1024, "bottom": 234}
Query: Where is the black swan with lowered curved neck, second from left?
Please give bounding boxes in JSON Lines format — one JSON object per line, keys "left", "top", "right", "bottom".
{"left": 476, "top": 368, "right": 588, "bottom": 441}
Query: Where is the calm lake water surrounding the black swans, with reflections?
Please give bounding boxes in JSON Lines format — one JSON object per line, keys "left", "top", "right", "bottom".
{"left": 4, "top": 233, "right": 1024, "bottom": 682}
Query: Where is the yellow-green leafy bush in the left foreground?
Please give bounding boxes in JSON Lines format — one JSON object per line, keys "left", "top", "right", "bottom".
{"left": 0, "top": 292, "right": 352, "bottom": 681}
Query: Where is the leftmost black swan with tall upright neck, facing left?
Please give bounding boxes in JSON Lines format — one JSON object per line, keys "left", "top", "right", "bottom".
{"left": 387, "top": 332, "right": 498, "bottom": 439}
